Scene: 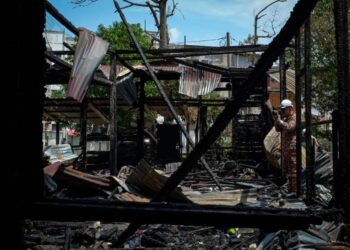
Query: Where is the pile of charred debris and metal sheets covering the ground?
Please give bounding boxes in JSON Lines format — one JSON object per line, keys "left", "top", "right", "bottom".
{"left": 25, "top": 146, "right": 350, "bottom": 249}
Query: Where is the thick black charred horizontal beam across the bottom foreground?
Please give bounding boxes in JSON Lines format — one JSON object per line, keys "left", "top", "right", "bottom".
{"left": 25, "top": 199, "right": 322, "bottom": 230}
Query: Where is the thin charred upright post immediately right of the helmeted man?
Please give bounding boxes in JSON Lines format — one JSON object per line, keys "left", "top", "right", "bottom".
{"left": 294, "top": 31, "right": 302, "bottom": 196}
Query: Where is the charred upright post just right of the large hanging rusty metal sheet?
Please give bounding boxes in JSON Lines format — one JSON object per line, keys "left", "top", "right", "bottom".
{"left": 109, "top": 55, "right": 118, "bottom": 175}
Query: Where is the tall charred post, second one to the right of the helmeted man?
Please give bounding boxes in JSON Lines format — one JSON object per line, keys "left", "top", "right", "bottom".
{"left": 304, "top": 17, "right": 315, "bottom": 204}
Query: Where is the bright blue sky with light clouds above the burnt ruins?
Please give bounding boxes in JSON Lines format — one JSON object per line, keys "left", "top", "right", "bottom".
{"left": 46, "top": 0, "right": 297, "bottom": 46}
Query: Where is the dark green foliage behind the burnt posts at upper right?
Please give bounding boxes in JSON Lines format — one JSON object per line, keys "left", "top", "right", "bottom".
{"left": 287, "top": 0, "right": 350, "bottom": 113}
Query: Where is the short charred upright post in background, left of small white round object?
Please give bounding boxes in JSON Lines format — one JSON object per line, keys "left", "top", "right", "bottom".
{"left": 137, "top": 79, "right": 145, "bottom": 160}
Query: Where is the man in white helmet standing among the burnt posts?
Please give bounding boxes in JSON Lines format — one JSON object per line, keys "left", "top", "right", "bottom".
{"left": 274, "top": 99, "right": 297, "bottom": 192}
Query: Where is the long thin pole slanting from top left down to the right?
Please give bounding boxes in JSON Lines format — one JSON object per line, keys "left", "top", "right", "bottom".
{"left": 113, "top": 0, "right": 222, "bottom": 190}
